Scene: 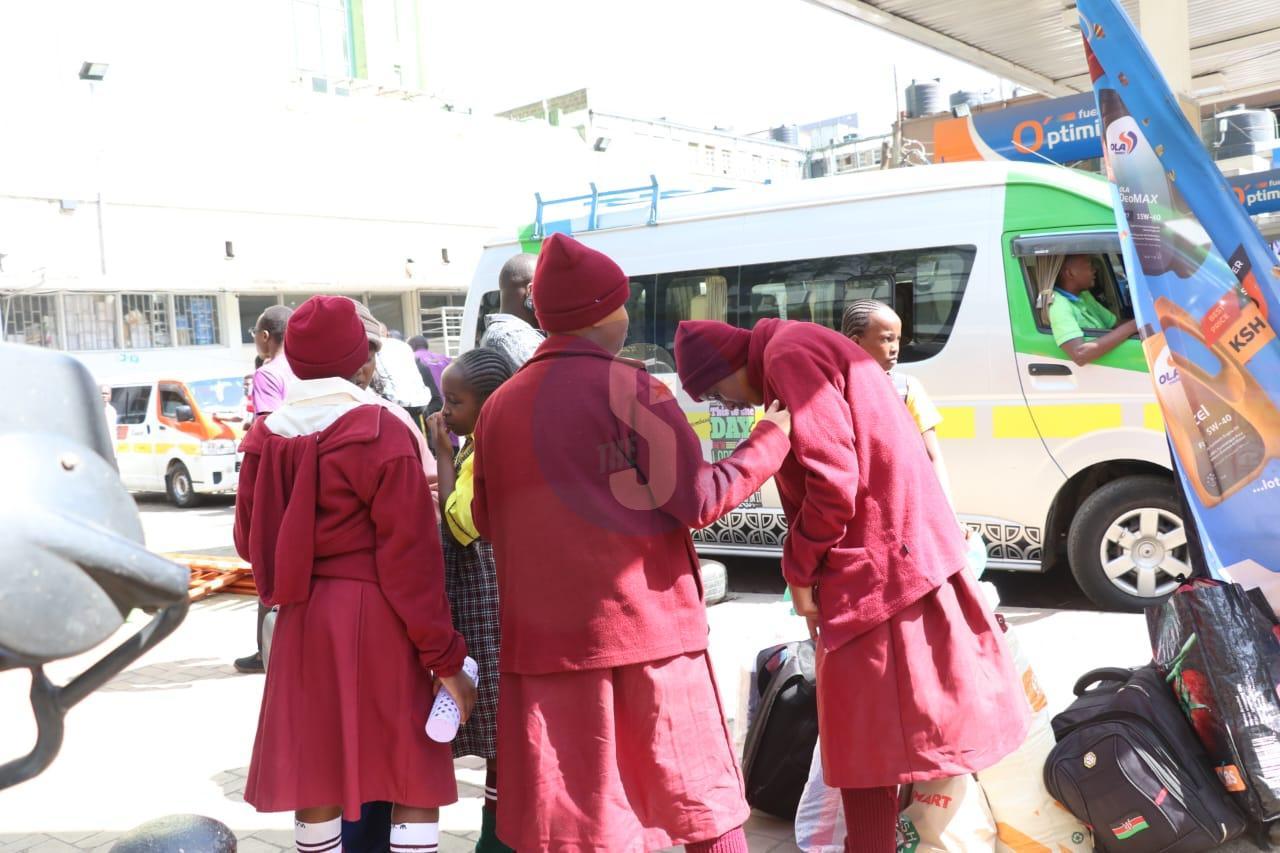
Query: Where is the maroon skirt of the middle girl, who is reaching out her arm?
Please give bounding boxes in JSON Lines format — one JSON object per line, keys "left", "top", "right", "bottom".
{"left": 498, "top": 652, "right": 750, "bottom": 853}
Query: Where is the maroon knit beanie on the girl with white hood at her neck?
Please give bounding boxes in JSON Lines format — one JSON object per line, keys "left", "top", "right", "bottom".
{"left": 284, "top": 296, "right": 369, "bottom": 379}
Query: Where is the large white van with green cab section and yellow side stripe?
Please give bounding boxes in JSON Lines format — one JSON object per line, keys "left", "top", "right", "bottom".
{"left": 463, "top": 163, "right": 1189, "bottom": 608}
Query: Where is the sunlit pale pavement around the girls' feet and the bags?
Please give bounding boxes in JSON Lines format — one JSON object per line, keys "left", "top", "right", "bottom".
{"left": 0, "top": 494, "right": 1252, "bottom": 853}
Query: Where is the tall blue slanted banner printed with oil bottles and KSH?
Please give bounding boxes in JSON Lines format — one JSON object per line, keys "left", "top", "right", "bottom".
{"left": 1078, "top": 0, "right": 1280, "bottom": 603}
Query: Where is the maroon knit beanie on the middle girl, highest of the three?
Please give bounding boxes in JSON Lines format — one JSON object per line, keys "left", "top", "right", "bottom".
{"left": 534, "top": 233, "right": 631, "bottom": 333}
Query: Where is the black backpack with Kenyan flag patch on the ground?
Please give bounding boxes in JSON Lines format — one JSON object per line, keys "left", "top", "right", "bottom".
{"left": 1044, "top": 665, "right": 1245, "bottom": 853}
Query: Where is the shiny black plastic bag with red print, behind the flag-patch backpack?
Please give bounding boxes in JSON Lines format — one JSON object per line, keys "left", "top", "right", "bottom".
{"left": 1147, "top": 580, "right": 1280, "bottom": 821}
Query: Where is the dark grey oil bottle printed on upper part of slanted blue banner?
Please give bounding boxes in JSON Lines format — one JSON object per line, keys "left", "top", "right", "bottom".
{"left": 1098, "top": 88, "right": 1212, "bottom": 278}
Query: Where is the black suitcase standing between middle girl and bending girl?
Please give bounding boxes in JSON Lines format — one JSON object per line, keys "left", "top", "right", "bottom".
{"left": 742, "top": 640, "right": 818, "bottom": 821}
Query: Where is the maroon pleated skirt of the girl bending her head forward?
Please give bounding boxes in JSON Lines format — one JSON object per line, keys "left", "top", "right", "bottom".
{"left": 817, "top": 570, "right": 1030, "bottom": 788}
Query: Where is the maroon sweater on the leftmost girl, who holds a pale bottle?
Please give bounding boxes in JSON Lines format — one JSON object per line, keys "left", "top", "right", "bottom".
{"left": 234, "top": 406, "right": 467, "bottom": 675}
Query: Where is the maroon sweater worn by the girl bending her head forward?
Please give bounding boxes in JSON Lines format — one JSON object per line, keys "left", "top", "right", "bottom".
{"left": 748, "top": 320, "right": 964, "bottom": 648}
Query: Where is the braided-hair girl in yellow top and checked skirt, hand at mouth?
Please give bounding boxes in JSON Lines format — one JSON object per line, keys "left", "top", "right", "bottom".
{"left": 426, "top": 347, "right": 515, "bottom": 853}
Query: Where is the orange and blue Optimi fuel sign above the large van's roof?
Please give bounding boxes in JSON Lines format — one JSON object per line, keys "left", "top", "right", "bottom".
{"left": 933, "top": 92, "right": 1102, "bottom": 164}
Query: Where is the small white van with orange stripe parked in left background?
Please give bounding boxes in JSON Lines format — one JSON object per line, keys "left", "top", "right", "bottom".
{"left": 108, "top": 377, "right": 247, "bottom": 507}
